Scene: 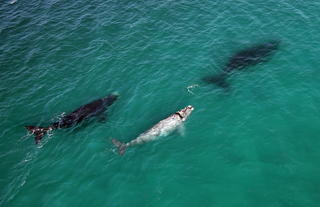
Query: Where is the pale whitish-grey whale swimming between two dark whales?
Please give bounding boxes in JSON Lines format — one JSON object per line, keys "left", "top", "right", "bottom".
{"left": 112, "top": 105, "right": 194, "bottom": 155}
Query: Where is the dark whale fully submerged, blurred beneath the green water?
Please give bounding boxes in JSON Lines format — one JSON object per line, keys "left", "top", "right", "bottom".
{"left": 202, "top": 40, "right": 280, "bottom": 88}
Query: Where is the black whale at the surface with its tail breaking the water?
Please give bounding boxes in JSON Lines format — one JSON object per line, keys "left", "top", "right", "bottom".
{"left": 25, "top": 94, "right": 118, "bottom": 144}
